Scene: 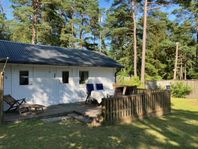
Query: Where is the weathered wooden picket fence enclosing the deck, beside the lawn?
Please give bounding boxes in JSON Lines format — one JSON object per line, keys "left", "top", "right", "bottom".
{"left": 102, "top": 89, "right": 171, "bottom": 123}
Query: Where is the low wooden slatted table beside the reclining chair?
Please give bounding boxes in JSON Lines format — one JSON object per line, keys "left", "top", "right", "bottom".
{"left": 19, "top": 103, "right": 45, "bottom": 114}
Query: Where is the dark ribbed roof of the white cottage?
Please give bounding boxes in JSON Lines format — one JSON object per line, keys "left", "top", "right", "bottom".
{"left": 0, "top": 40, "right": 123, "bottom": 68}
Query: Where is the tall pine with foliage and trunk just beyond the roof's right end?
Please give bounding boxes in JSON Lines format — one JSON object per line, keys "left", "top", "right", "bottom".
{"left": 107, "top": 0, "right": 140, "bottom": 76}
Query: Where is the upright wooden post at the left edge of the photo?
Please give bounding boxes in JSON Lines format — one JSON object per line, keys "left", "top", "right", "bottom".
{"left": 0, "top": 73, "right": 3, "bottom": 124}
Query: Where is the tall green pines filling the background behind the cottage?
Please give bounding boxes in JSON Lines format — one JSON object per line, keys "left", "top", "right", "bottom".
{"left": 0, "top": 0, "right": 198, "bottom": 80}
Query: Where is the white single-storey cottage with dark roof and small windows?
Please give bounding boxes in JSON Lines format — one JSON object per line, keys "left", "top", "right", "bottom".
{"left": 0, "top": 40, "right": 122, "bottom": 109}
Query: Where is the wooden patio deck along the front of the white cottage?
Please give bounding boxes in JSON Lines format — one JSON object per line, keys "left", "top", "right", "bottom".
{"left": 4, "top": 102, "right": 102, "bottom": 122}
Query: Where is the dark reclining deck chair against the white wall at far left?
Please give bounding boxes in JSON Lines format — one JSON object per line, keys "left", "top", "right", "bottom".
{"left": 3, "top": 95, "right": 26, "bottom": 112}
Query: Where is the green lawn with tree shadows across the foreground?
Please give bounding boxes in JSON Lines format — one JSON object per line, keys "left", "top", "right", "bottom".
{"left": 0, "top": 99, "right": 198, "bottom": 149}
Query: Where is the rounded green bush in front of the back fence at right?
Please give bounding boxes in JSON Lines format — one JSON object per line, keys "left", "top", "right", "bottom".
{"left": 171, "top": 82, "right": 192, "bottom": 98}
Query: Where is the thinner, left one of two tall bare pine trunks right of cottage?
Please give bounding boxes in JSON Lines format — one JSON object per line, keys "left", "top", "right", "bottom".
{"left": 132, "top": 0, "right": 137, "bottom": 77}
